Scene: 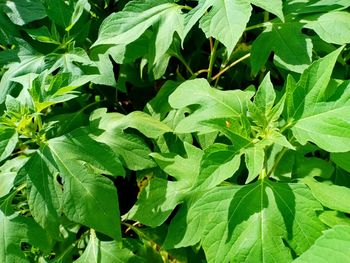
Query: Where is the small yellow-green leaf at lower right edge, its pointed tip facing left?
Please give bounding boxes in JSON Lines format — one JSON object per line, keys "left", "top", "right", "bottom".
{"left": 303, "top": 178, "right": 350, "bottom": 213}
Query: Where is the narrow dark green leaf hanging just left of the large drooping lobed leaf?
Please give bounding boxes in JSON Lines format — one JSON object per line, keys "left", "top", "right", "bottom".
{"left": 24, "top": 151, "right": 63, "bottom": 238}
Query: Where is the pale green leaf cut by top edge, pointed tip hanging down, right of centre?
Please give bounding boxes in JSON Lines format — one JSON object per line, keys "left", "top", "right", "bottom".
{"left": 199, "top": 0, "right": 252, "bottom": 54}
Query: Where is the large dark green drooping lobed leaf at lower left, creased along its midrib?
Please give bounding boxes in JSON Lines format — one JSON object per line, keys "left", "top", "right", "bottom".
{"left": 39, "top": 129, "right": 124, "bottom": 240}
